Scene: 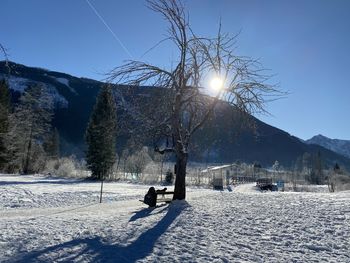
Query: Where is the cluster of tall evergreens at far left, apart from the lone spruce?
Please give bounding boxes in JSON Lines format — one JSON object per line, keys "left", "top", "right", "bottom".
{"left": 0, "top": 80, "right": 59, "bottom": 174}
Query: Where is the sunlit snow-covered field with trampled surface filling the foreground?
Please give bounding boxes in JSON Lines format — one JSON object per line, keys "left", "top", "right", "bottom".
{"left": 0, "top": 175, "right": 350, "bottom": 262}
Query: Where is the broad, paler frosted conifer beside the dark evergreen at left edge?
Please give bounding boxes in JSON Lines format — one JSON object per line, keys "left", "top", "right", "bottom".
{"left": 8, "top": 85, "right": 53, "bottom": 174}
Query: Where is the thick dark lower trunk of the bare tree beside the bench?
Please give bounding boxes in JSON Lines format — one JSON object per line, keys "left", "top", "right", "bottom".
{"left": 173, "top": 153, "right": 187, "bottom": 200}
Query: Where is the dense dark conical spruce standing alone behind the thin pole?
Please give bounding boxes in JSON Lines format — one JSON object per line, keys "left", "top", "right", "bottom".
{"left": 85, "top": 86, "right": 117, "bottom": 180}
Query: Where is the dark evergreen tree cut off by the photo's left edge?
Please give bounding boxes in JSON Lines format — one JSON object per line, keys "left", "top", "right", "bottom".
{"left": 0, "top": 79, "right": 11, "bottom": 170}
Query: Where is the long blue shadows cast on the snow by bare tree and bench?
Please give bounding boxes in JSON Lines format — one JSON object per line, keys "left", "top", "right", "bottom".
{"left": 13, "top": 205, "right": 186, "bottom": 263}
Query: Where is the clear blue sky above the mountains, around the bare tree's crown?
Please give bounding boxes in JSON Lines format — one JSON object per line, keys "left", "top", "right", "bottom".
{"left": 0, "top": 0, "right": 350, "bottom": 139}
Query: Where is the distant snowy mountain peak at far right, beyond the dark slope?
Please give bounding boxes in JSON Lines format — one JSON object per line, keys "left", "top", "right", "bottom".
{"left": 306, "top": 134, "right": 350, "bottom": 158}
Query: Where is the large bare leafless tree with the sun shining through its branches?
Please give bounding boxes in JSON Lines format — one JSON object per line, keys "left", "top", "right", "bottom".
{"left": 108, "top": 0, "right": 278, "bottom": 200}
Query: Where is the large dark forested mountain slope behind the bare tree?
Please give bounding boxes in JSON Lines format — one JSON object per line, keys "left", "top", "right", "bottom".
{"left": 0, "top": 62, "right": 350, "bottom": 169}
